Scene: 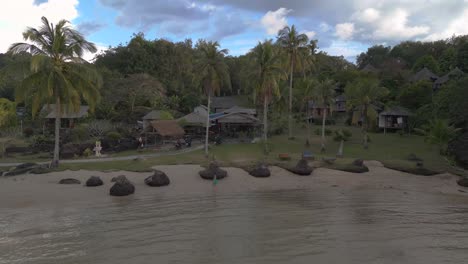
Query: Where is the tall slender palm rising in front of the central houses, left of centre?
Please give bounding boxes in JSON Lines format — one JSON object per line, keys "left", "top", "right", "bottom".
{"left": 196, "top": 40, "right": 231, "bottom": 156}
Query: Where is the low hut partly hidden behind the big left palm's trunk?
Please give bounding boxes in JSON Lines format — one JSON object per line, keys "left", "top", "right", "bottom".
{"left": 41, "top": 104, "right": 89, "bottom": 128}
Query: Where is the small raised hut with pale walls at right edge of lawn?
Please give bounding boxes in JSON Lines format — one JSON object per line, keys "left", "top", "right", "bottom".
{"left": 379, "top": 107, "right": 411, "bottom": 133}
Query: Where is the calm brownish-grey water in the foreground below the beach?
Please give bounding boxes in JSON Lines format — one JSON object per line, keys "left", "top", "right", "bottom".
{"left": 0, "top": 190, "right": 468, "bottom": 264}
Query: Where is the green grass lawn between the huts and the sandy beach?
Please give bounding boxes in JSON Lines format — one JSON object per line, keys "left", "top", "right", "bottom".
{"left": 41, "top": 126, "right": 460, "bottom": 175}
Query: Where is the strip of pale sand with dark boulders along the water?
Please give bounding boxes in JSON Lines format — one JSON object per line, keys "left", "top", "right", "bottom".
{"left": 0, "top": 161, "right": 468, "bottom": 208}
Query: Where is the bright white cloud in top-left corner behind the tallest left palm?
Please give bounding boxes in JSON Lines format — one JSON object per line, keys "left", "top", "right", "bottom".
{"left": 0, "top": 0, "right": 78, "bottom": 52}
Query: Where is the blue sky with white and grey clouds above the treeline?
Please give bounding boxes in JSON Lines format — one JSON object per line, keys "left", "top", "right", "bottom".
{"left": 0, "top": 0, "right": 468, "bottom": 61}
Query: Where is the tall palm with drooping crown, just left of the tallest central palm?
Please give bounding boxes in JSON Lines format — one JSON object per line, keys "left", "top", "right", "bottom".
{"left": 253, "top": 40, "right": 284, "bottom": 154}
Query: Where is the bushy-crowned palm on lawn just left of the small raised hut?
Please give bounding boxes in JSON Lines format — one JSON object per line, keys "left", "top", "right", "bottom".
{"left": 345, "top": 77, "right": 388, "bottom": 149}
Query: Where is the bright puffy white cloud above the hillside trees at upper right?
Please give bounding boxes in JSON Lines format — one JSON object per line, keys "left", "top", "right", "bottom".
{"left": 373, "top": 8, "right": 430, "bottom": 40}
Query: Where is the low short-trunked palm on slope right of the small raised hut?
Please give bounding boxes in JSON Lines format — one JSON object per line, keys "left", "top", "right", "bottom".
{"left": 415, "top": 118, "right": 461, "bottom": 155}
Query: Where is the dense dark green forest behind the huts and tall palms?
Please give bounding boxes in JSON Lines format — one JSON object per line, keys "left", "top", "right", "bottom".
{"left": 0, "top": 30, "right": 468, "bottom": 167}
